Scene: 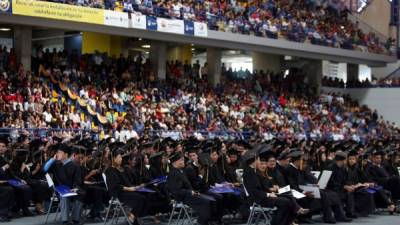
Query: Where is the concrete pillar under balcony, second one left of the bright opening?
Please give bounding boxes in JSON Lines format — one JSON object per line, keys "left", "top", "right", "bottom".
{"left": 150, "top": 41, "right": 167, "bottom": 80}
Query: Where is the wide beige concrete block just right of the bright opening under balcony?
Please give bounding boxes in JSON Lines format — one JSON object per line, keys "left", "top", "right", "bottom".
{"left": 252, "top": 52, "right": 281, "bottom": 73}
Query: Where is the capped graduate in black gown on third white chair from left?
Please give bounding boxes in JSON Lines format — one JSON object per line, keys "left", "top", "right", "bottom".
{"left": 167, "top": 152, "right": 214, "bottom": 225}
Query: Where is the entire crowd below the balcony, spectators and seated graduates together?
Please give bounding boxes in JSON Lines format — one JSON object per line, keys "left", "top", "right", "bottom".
{"left": 0, "top": 47, "right": 400, "bottom": 225}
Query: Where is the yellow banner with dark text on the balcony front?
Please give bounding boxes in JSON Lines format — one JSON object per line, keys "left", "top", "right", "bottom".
{"left": 12, "top": 0, "right": 104, "bottom": 24}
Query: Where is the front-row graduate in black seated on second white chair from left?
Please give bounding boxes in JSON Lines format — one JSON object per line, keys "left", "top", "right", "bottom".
{"left": 105, "top": 148, "right": 146, "bottom": 225}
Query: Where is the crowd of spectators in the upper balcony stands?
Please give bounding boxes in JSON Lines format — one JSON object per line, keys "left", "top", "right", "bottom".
{"left": 43, "top": 0, "right": 394, "bottom": 54}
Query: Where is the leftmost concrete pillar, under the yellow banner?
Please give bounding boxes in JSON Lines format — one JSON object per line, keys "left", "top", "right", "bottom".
{"left": 14, "top": 26, "right": 32, "bottom": 71}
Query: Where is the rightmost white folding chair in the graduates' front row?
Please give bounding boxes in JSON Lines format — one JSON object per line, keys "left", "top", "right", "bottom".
{"left": 243, "top": 184, "right": 276, "bottom": 225}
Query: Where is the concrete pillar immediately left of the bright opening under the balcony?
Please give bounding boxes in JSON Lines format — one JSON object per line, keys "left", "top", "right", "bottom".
{"left": 207, "top": 48, "right": 222, "bottom": 86}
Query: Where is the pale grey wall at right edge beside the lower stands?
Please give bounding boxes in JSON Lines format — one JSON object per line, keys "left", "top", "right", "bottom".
{"left": 322, "top": 87, "right": 400, "bottom": 125}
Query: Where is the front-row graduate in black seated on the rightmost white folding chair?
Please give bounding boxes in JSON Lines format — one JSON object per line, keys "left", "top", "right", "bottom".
{"left": 243, "top": 149, "right": 296, "bottom": 225}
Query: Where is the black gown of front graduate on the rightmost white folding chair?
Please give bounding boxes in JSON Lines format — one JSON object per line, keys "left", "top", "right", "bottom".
{"left": 243, "top": 167, "right": 296, "bottom": 225}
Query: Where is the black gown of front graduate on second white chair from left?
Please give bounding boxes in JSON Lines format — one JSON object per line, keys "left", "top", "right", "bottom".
{"left": 105, "top": 167, "right": 146, "bottom": 217}
